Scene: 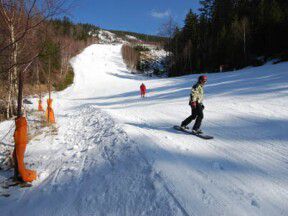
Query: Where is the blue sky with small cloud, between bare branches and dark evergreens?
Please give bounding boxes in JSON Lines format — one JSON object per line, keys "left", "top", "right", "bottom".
{"left": 70, "top": 0, "right": 199, "bottom": 34}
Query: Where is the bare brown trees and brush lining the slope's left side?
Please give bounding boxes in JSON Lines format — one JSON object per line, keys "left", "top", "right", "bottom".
{"left": 0, "top": 9, "right": 98, "bottom": 119}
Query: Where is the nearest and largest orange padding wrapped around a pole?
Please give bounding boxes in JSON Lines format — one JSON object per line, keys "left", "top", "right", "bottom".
{"left": 13, "top": 117, "right": 37, "bottom": 182}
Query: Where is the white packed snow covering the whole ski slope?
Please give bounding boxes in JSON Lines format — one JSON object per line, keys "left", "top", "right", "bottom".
{"left": 0, "top": 45, "right": 288, "bottom": 216}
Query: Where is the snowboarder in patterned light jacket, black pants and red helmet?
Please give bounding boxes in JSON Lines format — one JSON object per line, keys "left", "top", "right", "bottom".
{"left": 181, "top": 75, "right": 208, "bottom": 134}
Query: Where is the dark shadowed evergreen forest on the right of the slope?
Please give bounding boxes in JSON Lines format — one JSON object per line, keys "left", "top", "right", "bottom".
{"left": 167, "top": 0, "right": 288, "bottom": 76}
